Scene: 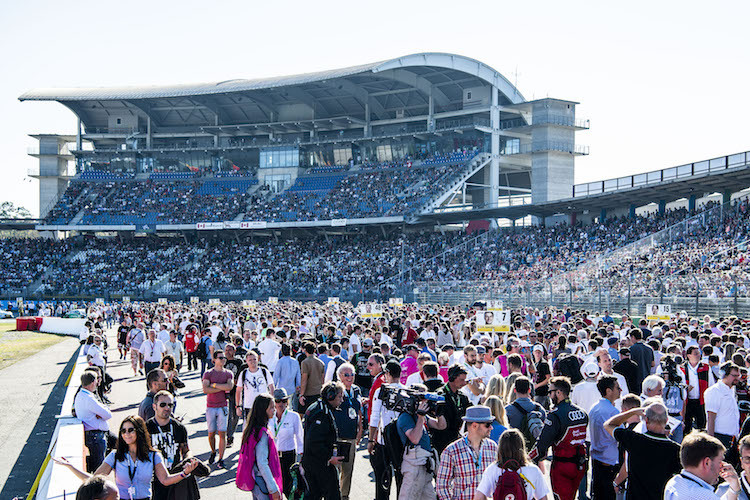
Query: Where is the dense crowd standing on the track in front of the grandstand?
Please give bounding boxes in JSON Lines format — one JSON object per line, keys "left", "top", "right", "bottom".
{"left": 60, "top": 302, "right": 750, "bottom": 500}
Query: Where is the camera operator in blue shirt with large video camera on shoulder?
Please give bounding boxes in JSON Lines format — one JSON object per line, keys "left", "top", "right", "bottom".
{"left": 396, "top": 384, "right": 446, "bottom": 500}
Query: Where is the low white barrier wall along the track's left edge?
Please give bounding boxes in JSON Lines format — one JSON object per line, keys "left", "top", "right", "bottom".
{"left": 32, "top": 348, "right": 88, "bottom": 500}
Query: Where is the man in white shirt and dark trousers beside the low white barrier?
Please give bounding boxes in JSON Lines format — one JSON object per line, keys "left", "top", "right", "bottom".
{"left": 73, "top": 368, "right": 112, "bottom": 472}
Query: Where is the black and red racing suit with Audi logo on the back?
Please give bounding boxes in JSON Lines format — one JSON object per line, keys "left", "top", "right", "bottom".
{"left": 529, "top": 399, "right": 589, "bottom": 500}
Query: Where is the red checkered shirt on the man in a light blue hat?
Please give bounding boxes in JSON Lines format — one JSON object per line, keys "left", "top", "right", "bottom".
{"left": 435, "top": 437, "right": 497, "bottom": 500}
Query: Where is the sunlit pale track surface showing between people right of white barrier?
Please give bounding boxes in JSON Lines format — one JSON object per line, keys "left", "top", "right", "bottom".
{"left": 100, "top": 330, "right": 396, "bottom": 500}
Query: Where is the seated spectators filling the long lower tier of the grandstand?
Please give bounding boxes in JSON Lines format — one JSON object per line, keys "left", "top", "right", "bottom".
{"left": 5, "top": 196, "right": 750, "bottom": 297}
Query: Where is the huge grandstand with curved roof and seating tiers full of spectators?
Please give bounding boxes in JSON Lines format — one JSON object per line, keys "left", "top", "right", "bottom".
{"left": 10, "top": 53, "right": 750, "bottom": 314}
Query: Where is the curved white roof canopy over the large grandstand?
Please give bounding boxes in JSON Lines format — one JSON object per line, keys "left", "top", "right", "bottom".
{"left": 19, "top": 53, "right": 525, "bottom": 129}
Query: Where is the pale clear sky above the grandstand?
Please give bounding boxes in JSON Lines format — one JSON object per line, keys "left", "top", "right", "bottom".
{"left": 0, "top": 0, "right": 750, "bottom": 214}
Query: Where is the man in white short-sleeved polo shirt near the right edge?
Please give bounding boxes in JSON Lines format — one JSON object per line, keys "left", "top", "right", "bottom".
{"left": 703, "top": 361, "right": 740, "bottom": 449}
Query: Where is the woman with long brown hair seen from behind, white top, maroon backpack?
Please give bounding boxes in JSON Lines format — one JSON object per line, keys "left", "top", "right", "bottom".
{"left": 474, "top": 429, "right": 550, "bottom": 500}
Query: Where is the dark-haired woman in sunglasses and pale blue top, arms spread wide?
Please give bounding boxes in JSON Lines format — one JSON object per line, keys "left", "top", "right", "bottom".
{"left": 53, "top": 415, "right": 198, "bottom": 500}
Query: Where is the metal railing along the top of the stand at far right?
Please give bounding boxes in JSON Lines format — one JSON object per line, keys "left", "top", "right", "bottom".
{"left": 573, "top": 151, "right": 750, "bottom": 198}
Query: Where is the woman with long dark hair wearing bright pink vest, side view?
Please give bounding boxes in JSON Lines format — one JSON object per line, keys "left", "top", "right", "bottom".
{"left": 236, "top": 394, "right": 283, "bottom": 500}
